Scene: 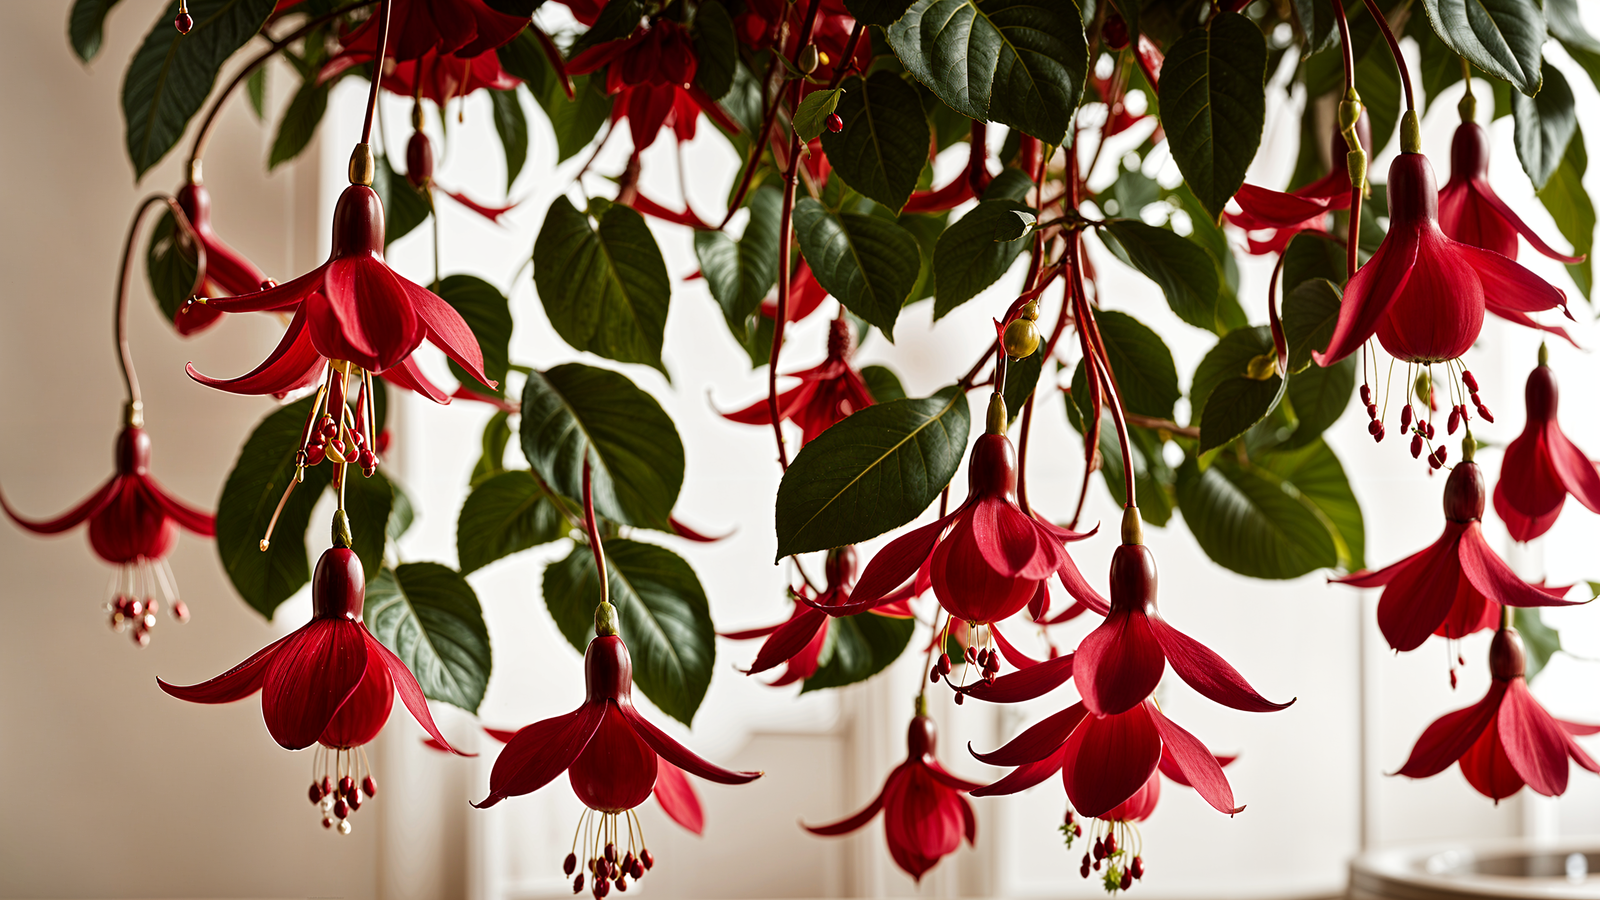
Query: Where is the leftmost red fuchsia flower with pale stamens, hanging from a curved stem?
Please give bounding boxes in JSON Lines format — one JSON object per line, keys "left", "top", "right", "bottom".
{"left": 0, "top": 424, "right": 216, "bottom": 647}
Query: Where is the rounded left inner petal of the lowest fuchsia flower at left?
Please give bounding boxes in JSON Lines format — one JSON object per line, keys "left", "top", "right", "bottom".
{"left": 261, "top": 618, "right": 368, "bottom": 749}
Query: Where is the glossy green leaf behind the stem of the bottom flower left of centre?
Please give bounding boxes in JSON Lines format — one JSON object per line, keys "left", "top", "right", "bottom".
{"left": 544, "top": 538, "right": 717, "bottom": 725}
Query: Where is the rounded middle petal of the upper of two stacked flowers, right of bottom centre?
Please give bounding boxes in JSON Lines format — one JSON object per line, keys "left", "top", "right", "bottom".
{"left": 1072, "top": 610, "right": 1166, "bottom": 716}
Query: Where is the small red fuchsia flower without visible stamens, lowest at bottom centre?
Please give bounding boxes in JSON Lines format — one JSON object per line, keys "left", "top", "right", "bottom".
{"left": 802, "top": 703, "right": 979, "bottom": 882}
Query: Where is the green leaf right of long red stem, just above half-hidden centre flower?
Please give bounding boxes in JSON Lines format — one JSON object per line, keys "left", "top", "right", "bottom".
{"left": 794, "top": 197, "right": 922, "bottom": 341}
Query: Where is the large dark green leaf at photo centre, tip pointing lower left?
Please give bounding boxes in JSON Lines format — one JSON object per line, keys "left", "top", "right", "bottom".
{"left": 778, "top": 386, "right": 971, "bottom": 559}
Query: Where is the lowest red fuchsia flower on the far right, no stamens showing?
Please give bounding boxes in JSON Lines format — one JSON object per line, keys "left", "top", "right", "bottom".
{"left": 1397, "top": 626, "right": 1600, "bottom": 802}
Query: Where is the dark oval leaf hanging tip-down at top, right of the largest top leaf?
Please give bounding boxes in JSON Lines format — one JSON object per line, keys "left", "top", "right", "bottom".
{"left": 1160, "top": 13, "right": 1267, "bottom": 218}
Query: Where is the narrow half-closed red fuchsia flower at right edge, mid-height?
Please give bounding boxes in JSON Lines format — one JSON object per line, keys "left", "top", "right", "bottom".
{"left": 1494, "top": 348, "right": 1600, "bottom": 541}
